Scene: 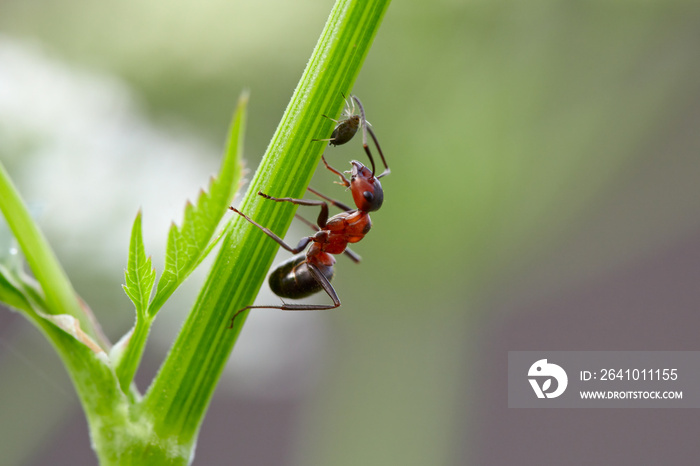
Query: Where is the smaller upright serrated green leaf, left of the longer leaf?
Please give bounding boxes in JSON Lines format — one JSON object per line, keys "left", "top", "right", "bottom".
{"left": 122, "top": 210, "right": 156, "bottom": 315}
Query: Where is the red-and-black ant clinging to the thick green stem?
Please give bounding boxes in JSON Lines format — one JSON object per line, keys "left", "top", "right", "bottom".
{"left": 229, "top": 156, "right": 384, "bottom": 328}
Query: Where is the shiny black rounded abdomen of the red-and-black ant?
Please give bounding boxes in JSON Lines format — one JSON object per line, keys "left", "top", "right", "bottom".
{"left": 269, "top": 254, "right": 333, "bottom": 299}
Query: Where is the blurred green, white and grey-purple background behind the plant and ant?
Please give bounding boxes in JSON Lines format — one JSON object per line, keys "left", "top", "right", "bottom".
{"left": 0, "top": 0, "right": 700, "bottom": 466}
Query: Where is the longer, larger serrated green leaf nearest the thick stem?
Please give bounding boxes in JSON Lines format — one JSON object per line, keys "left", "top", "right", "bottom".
{"left": 148, "top": 94, "right": 248, "bottom": 316}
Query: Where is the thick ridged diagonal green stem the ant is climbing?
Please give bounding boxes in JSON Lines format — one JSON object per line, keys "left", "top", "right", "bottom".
{"left": 132, "top": 0, "right": 389, "bottom": 460}
